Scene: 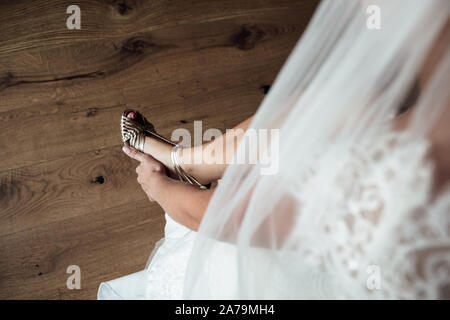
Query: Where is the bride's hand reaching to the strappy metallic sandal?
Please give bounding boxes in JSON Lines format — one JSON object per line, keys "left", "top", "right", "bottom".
{"left": 122, "top": 146, "right": 167, "bottom": 202}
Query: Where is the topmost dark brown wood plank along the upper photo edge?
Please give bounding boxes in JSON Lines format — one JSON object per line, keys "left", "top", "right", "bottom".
{"left": 0, "top": 0, "right": 318, "bottom": 55}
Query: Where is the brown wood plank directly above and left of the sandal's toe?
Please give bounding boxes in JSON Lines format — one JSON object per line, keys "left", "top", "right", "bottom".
{"left": 0, "top": 8, "right": 312, "bottom": 171}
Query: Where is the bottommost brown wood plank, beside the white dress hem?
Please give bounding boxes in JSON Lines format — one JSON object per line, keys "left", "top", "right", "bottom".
{"left": 0, "top": 200, "right": 164, "bottom": 299}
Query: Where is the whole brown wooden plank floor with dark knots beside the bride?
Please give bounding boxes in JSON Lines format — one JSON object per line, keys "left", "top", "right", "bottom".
{"left": 0, "top": 0, "right": 317, "bottom": 299}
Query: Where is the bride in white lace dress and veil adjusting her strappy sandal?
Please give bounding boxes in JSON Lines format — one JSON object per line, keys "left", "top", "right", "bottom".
{"left": 98, "top": 0, "right": 450, "bottom": 299}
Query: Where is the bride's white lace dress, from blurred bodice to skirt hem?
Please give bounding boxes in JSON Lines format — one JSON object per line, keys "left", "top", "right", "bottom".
{"left": 98, "top": 133, "right": 450, "bottom": 299}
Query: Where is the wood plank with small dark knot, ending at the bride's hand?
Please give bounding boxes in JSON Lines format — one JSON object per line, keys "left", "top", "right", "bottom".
{"left": 0, "top": 147, "right": 146, "bottom": 235}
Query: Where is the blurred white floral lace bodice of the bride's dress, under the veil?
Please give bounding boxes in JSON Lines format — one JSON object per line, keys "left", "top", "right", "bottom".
{"left": 284, "top": 132, "right": 450, "bottom": 299}
